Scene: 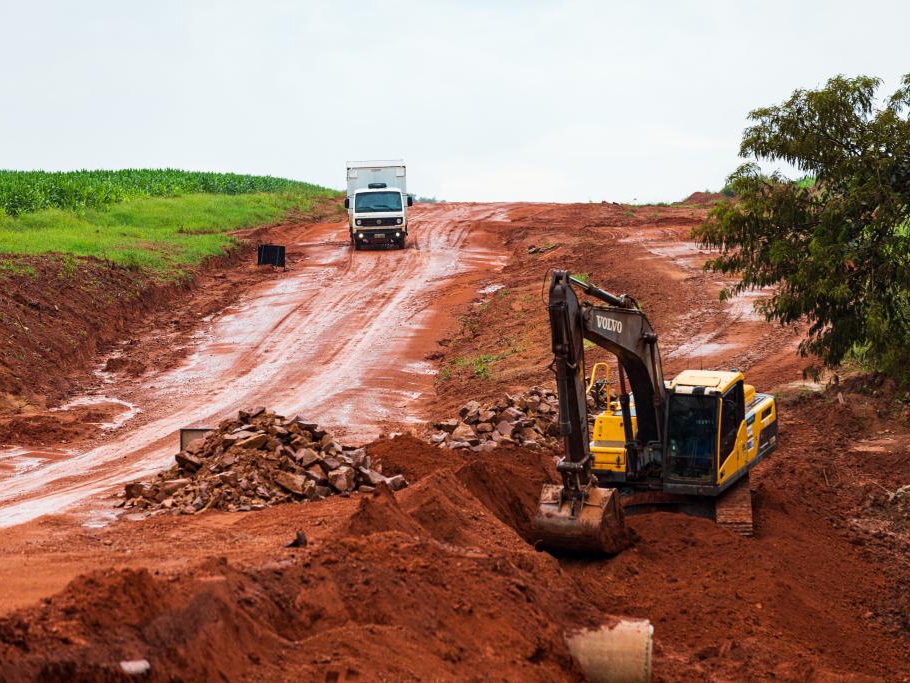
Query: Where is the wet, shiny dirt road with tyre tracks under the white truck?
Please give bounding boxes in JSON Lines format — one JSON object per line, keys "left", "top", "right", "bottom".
{"left": 0, "top": 204, "right": 503, "bottom": 527}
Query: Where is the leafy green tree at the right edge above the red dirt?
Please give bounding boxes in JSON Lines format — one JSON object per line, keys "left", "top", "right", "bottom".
{"left": 694, "top": 75, "right": 910, "bottom": 380}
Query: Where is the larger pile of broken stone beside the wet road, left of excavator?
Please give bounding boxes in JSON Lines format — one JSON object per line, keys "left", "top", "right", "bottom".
{"left": 124, "top": 408, "right": 407, "bottom": 514}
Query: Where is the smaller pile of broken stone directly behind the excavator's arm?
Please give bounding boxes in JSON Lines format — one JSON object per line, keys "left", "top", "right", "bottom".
{"left": 427, "top": 387, "right": 560, "bottom": 451}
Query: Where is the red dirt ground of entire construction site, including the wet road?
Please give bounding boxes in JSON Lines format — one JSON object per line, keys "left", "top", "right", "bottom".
{"left": 0, "top": 196, "right": 910, "bottom": 682}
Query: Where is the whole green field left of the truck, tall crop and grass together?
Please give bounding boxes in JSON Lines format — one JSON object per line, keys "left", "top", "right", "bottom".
{"left": 0, "top": 169, "right": 339, "bottom": 277}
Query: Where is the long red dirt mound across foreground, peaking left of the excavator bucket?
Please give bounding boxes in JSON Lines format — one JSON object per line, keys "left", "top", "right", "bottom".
{"left": 0, "top": 444, "right": 605, "bottom": 681}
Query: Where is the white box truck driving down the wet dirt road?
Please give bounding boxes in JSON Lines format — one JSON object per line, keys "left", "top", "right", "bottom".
{"left": 344, "top": 159, "right": 414, "bottom": 249}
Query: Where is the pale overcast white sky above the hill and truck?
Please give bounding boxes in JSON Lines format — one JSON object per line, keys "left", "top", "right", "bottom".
{"left": 0, "top": 0, "right": 910, "bottom": 201}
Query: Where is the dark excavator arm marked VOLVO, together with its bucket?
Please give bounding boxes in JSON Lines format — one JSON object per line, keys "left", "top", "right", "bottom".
{"left": 535, "top": 270, "right": 665, "bottom": 553}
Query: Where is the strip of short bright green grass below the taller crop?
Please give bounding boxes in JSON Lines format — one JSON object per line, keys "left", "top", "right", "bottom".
{"left": 0, "top": 186, "right": 335, "bottom": 276}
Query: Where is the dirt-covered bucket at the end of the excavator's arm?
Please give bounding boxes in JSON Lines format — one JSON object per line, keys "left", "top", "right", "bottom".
{"left": 534, "top": 484, "right": 631, "bottom": 555}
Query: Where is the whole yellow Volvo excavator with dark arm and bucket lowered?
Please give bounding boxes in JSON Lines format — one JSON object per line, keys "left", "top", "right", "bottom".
{"left": 534, "top": 270, "right": 777, "bottom": 554}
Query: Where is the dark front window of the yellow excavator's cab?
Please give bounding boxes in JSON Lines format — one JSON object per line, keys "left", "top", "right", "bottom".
{"left": 667, "top": 394, "right": 719, "bottom": 481}
